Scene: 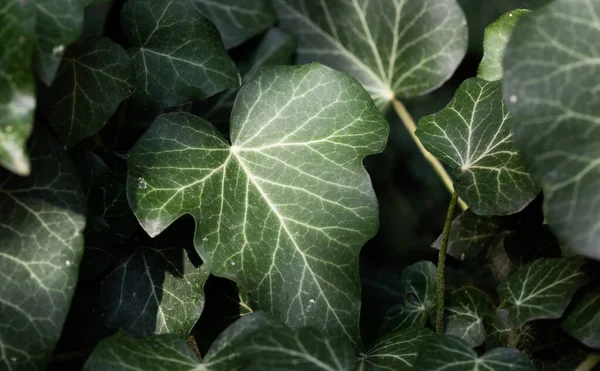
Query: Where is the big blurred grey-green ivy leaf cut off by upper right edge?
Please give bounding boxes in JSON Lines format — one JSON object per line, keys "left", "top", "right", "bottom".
{"left": 504, "top": 0, "right": 600, "bottom": 259}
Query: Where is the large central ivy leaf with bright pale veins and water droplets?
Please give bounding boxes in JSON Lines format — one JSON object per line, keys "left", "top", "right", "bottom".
{"left": 127, "top": 64, "right": 388, "bottom": 341}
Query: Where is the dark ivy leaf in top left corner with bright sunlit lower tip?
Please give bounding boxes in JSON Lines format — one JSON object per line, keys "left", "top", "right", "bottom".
{"left": 0, "top": 0, "right": 35, "bottom": 175}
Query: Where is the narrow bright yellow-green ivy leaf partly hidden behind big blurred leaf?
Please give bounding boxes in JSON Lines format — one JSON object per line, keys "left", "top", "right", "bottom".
{"left": 477, "top": 9, "right": 530, "bottom": 81}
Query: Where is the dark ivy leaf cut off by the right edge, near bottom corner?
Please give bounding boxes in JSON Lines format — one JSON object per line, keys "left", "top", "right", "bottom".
{"left": 562, "top": 288, "right": 600, "bottom": 349}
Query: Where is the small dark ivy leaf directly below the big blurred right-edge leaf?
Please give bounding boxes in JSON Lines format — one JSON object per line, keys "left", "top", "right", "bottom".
{"left": 498, "top": 258, "right": 586, "bottom": 327}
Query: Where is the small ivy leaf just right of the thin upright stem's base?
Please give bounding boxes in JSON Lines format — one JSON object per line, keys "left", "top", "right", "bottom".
{"left": 444, "top": 287, "right": 495, "bottom": 347}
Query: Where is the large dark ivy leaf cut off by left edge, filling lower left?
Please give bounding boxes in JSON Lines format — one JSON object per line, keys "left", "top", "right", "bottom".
{"left": 0, "top": 126, "right": 85, "bottom": 370}
